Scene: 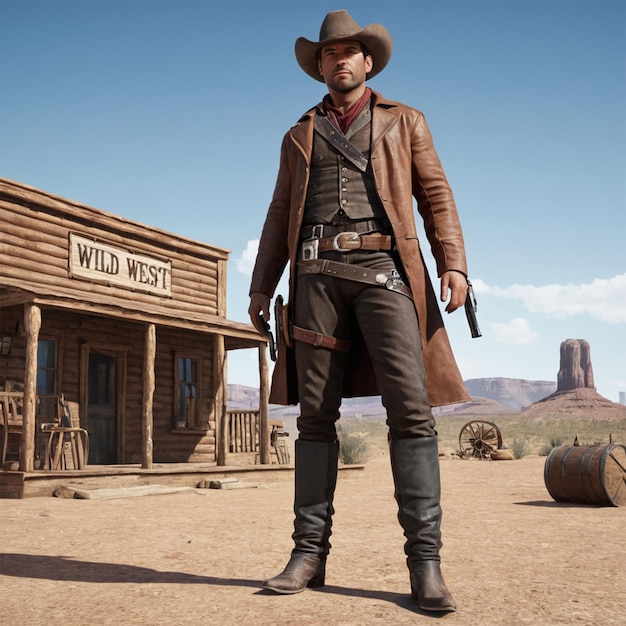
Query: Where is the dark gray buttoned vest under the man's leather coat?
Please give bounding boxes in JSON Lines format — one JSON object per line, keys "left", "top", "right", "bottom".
{"left": 303, "top": 106, "right": 385, "bottom": 225}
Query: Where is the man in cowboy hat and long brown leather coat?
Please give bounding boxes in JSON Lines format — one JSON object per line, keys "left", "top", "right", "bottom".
{"left": 249, "top": 11, "right": 468, "bottom": 611}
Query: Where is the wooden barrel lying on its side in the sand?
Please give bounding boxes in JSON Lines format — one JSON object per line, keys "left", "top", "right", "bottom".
{"left": 543, "top": 443, "right": 626, "bottom": 506}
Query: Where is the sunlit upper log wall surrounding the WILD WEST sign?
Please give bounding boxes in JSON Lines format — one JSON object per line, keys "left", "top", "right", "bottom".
{"left": 0, "top": 179, "right": 228, "bottom": 317}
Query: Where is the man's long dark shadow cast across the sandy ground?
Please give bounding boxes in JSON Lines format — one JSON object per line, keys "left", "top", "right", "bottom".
{"left": 0, "top": 552, "right": 445, "bottom": 617}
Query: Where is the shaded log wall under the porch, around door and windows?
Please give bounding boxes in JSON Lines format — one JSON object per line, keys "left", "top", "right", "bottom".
{"left": 0, "top": 306, "right": 218, "bottom": 463}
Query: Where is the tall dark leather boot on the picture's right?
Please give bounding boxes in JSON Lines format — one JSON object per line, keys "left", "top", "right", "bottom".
{"left": 390, "top": 437, "right": 456, "bottom": 611}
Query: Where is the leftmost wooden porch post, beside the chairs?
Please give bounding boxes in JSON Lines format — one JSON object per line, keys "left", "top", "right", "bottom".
{"left": 20, "top": 302, "right": 41, "bottom": 472}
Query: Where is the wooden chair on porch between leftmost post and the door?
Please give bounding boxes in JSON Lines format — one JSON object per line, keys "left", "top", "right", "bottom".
{"left": 42, "top": 395, "right": 89, "bottom": 470}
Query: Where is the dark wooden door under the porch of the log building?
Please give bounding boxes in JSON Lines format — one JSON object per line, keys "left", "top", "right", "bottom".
{"left": 87, "top": 351, "right": 118, "bottom": 465}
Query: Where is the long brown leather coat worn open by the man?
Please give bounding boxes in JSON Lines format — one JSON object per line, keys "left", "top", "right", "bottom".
{"left": 250, "top": 92, "right": 469, "bottom": 406}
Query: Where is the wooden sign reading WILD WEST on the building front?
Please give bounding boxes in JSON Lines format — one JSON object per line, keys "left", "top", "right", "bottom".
{"left": 69, "top": 233, "right": 172, "bottom": 297}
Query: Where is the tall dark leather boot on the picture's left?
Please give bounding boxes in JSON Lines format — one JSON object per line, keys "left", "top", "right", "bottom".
{"left": 263, "top": 439, "right": 339, "bottom": 593}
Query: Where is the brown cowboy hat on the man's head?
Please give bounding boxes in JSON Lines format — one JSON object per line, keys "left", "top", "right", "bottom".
{"left": 296, "top": 10, "right": 393, "bottom": 83}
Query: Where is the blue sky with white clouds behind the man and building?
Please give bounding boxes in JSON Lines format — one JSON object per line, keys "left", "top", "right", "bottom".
{"left": 0, "top": 0, "right": 626, "bottom": 401}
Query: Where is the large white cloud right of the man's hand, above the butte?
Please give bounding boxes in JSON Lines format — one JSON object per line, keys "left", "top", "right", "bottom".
{"left": 472, "top": 274, "right": 626, "bottom": 324}
